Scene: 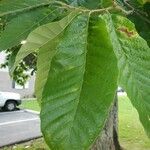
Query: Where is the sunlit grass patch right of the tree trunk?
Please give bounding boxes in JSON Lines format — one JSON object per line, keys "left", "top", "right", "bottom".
{"left": 119, "top": 96, "right": 150, "bottom": 150}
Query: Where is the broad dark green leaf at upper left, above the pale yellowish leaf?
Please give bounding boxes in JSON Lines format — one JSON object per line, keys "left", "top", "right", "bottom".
{"left": 0, "top": 8, "right": 59, "bottom": 51}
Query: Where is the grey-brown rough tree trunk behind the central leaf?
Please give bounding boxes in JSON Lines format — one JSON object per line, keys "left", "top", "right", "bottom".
{"left": 91, "top": 96, "right": 121, "bottom": 150}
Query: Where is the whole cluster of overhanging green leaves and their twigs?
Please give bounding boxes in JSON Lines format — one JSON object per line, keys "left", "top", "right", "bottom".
{"left": 0, "top": 0, "right": 150, "bottom": 150}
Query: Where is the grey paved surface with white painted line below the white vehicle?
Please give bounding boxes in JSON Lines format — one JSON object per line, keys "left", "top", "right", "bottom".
{"left": 0, "top": 110, "right": 41, "bottom": 147}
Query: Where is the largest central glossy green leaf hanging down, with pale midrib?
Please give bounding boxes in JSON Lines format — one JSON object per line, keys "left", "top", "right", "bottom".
{"left": 39, "top": 14, "right": 118, "bottom": 150}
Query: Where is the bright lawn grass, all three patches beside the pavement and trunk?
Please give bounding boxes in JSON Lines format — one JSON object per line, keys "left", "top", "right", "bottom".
{"left": 5, "top": 96, "right": 150, "bottom": 150}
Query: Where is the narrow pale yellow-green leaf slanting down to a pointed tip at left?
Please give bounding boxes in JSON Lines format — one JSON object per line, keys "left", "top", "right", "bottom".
{"left": 12, "top": 11, "right": 79, "bottom": 72}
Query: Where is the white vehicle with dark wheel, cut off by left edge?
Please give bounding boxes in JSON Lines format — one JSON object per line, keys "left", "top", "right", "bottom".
{"left": 0, "top": 92, "right": 21, "bottom": 111}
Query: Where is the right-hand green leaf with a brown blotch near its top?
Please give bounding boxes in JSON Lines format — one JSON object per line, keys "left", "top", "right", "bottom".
{"left": 103, "top": 15, "right": 150, "bottom": 136}
